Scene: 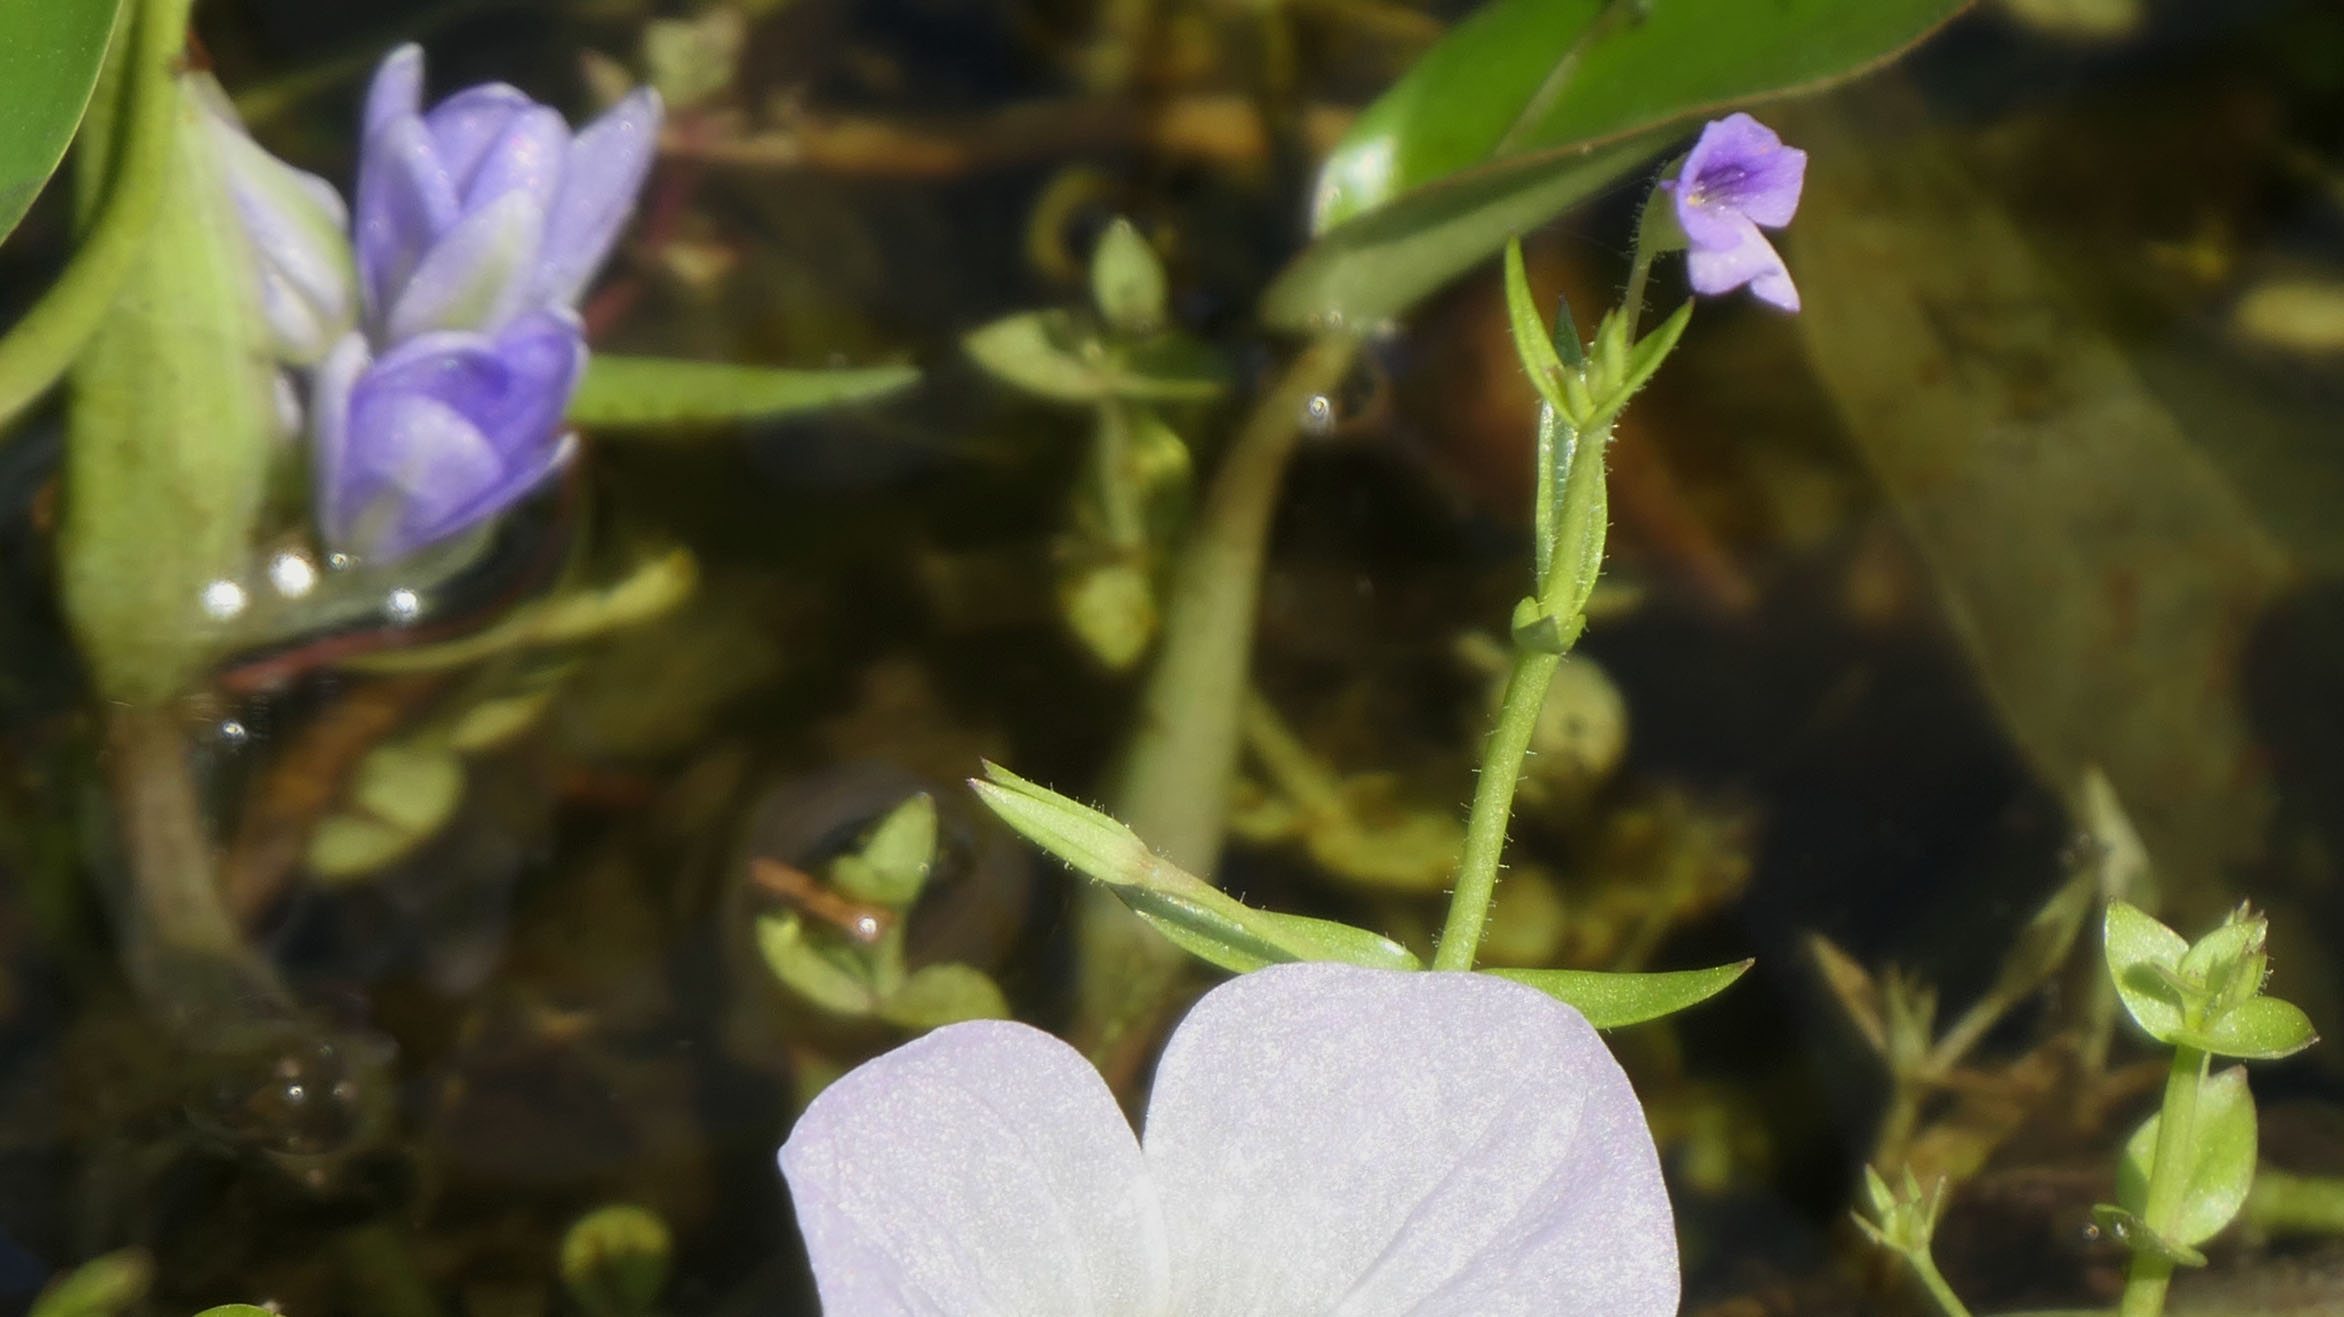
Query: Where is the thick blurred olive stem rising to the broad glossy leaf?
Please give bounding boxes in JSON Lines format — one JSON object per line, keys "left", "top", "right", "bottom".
{"left": 1071, "top": 333, "right": 1360, "bottom": 1049}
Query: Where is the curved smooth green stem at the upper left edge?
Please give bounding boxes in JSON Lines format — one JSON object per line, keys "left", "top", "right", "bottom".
{"left": 0, "top": 0, "right": 192, "bottom": 424}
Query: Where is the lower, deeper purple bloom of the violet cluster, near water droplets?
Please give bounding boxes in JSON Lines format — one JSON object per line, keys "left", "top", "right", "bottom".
{"left": 309, "top": 307, "right": 586, "bottom": 560}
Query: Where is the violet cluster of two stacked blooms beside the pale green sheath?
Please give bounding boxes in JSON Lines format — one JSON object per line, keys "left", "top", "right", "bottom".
{"left": 309, "top": 45, "right": 661, "bottom": 560}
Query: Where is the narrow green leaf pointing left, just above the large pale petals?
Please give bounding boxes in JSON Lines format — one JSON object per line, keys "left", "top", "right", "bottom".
{"left": 968, "top": 764, "right": 1420, "bottom": 975}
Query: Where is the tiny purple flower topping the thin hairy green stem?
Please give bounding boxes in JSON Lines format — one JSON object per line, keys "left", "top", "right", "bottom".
{"left": 1662, "top": 115, "right": 1807, "bottom": 312}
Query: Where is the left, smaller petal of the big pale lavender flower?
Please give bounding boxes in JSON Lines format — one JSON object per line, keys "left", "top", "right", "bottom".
{"left": 781, "top": 1019, "right": 1167, "bottom": 1317}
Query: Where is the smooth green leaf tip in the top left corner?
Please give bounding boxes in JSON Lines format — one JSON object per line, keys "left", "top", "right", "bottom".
{"left": 0, "top": 0, "right": 117, "bottom": 239}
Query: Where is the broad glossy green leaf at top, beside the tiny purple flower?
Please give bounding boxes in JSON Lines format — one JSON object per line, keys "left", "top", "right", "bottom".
{"left": 1263, "top": 0, "right": 1967, "bottom": 328}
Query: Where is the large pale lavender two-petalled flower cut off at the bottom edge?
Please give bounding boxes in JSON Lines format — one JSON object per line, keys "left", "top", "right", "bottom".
{"left": 781, "top": 963, "right": 1678, "bottom": 1317}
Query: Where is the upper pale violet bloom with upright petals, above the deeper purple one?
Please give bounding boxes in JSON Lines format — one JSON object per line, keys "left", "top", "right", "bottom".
{"left": 356, "top": 45, "right": 659, "bottom": 347}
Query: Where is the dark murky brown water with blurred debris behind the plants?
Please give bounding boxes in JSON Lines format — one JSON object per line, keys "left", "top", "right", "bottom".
{"left": 0, "top": 0, "right": 2344, "bottom": 1317}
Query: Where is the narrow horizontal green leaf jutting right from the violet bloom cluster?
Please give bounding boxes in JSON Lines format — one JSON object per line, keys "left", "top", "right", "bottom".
{"left": 570, "top": 352, "right": 919, "bottom": 429}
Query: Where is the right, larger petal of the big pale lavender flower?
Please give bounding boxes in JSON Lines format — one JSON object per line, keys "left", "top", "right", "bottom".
{"left": 1146, "top": 963, "right": 1678, "bottom": 1317}
